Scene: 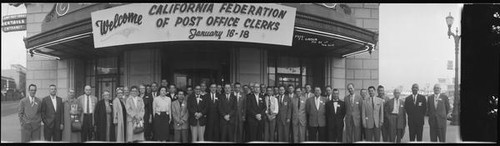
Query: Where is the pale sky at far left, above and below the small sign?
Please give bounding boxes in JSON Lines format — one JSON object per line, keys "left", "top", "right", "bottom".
{"left": 1, "top": 3, "right": 26, "bottom": 69}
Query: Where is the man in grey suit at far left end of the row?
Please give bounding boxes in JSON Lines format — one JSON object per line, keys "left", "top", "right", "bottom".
{"left": 17, "top": 84, "right": 42, "bottom": 142}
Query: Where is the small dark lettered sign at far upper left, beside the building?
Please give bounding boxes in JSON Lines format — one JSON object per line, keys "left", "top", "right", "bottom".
{"left": 2, "top": 13, "right": 26, "bottom": 32}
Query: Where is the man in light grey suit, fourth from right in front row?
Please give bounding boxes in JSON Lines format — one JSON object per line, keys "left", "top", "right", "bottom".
{"left": 361, "top": 86, "right": 384, "bottom": 141}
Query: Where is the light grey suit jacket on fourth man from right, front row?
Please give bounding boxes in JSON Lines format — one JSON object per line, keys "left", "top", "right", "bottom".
{"left": 361, "top": 97, "right": 384, "bottom": 128}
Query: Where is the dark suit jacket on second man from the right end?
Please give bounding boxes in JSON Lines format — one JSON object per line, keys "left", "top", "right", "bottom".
{"left": 404, "top": 94, "right": 427, "bottom": 125}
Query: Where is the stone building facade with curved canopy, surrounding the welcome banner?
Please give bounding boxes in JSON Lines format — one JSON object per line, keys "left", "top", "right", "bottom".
{"left": 20, "top": 3, "right": 379, "bottom": 101}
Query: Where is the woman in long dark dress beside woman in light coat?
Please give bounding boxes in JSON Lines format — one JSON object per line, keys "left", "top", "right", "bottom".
{"left": 94, "top": 90, "right": 116, "bottom": 141}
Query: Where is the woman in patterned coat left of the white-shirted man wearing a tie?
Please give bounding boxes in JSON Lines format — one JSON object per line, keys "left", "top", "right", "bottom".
{"left": 63, "top": 89, "right": 81, "bottom": 142}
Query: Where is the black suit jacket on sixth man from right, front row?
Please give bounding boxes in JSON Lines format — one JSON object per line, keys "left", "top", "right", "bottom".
{"left": 325, "top": 99, "right": 346, "bottom": 129}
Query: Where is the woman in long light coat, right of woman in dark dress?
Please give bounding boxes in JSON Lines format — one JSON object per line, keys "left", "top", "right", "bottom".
{"left": 113, "top": 88, "right": 127, "bottom": 142}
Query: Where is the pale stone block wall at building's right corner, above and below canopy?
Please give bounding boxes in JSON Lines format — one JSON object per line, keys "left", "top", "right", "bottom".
{"left": 341, "top": 3, "right": 379, "bottom": 93}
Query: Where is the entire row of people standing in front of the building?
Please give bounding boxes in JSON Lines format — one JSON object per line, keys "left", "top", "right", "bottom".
{"left": 19, "top": 80, "right": 451, "bottom": 143}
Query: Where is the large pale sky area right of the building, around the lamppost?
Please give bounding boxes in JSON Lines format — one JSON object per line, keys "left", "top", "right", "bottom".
{"left": 379, "top": 4, "right": 463, "bottom": 90}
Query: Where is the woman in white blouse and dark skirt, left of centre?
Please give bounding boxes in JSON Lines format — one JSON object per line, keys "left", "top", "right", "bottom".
{"left": 153, "top": 86, "right": 172, "bottom": 141}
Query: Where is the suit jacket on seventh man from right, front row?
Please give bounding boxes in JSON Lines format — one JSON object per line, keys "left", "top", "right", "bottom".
{"left": 306, "top": 96, "right": 327, "bottom": 127}
